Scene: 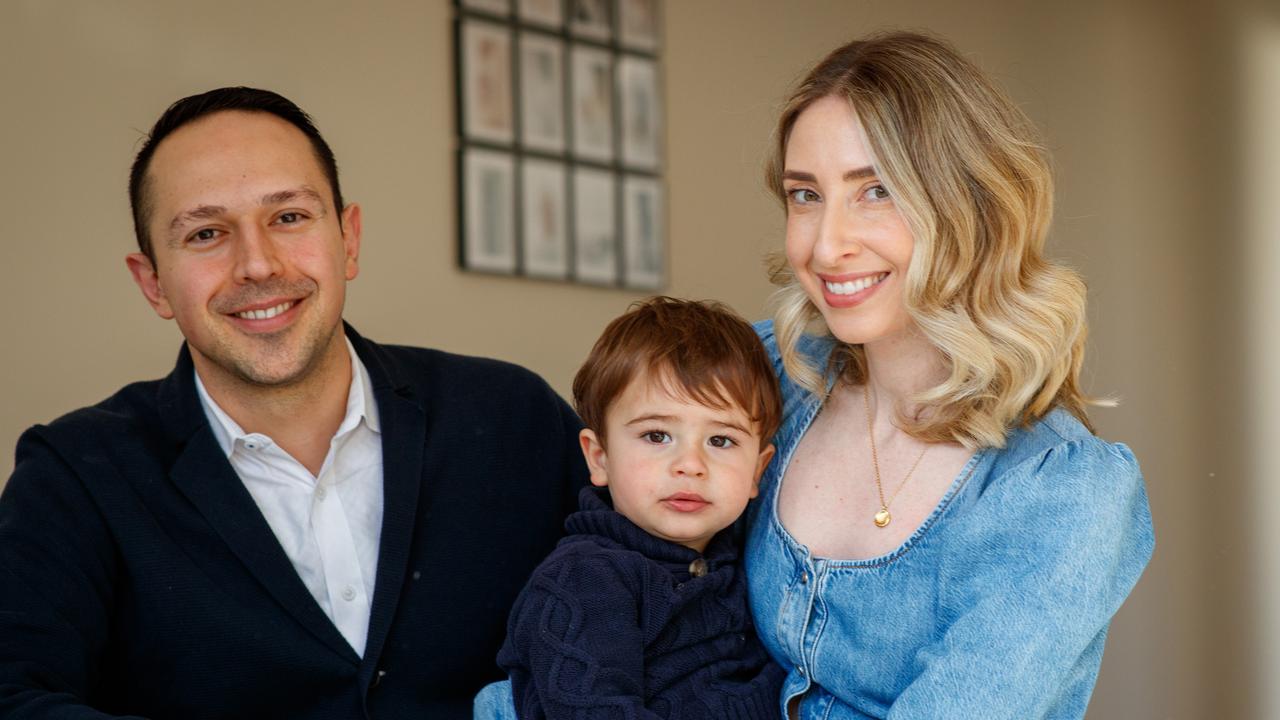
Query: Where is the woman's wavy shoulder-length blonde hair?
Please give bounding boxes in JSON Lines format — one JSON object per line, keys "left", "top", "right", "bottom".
{"left": 765, "top": 32, "right": 1105, "bottom": 448}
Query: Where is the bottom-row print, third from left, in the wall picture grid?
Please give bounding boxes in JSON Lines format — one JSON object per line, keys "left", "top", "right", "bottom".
{"left": 573, "top": 168, "right": 618, "bottom": 284}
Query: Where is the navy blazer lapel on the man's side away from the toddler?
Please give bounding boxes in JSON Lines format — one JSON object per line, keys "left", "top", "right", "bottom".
{"left": 160, "top": 346, "right": 360, "bottom": 664}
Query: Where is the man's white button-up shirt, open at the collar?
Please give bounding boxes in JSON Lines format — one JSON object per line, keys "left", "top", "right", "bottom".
{"left": 196, "top": 340, "right": 383, "bottom": 656}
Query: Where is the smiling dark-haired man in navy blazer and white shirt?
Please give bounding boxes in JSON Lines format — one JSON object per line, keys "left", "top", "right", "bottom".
{"left": 0, "top": 88, "right": 585, "bottom": 720}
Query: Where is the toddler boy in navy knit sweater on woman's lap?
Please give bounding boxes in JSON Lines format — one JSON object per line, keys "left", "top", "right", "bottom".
{"left": 488, "top": 297, "right": 783, "bottom": 720}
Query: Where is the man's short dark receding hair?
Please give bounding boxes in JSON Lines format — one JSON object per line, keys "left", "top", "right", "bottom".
{"left": 129, "top": 87, "right": 343, "bottom": 263}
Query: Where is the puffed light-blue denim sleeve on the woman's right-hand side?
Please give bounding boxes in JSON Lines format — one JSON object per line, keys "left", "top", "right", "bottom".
{"left": 888, "top": 436, "right": 1155, "bottom": 720}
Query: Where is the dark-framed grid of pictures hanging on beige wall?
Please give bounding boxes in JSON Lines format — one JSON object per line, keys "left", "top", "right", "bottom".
{"left": 454, "top": 0, "right": 667, "bottom": 290}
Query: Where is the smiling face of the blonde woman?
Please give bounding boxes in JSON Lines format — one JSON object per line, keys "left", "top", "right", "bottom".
{"left": 782, "top": 96, "right": 914, "bottom": 345}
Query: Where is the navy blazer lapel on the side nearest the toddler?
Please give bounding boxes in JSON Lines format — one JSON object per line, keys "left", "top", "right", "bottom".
{"left": 347, "top": 327, "right": 428, "bottom": 683}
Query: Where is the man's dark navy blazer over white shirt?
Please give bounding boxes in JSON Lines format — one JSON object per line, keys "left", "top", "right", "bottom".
{"left": 0, "top": 328, "right": 586, "bottom": 720}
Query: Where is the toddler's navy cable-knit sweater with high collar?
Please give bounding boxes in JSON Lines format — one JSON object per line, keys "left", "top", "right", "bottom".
{"left": 498, "top": 488, "right": 783, "bottom": 720}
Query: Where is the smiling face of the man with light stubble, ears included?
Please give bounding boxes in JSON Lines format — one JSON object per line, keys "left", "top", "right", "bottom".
{"left": 127, "top": 111, "right": 360, "bottom": 387}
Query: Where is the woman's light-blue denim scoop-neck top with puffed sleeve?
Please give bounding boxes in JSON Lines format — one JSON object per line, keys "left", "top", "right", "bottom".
{"left": 746, "top": 322, "right": 1155, "bottom": 720}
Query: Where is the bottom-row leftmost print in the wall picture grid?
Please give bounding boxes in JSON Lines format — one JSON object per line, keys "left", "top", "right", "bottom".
{"left": 462, "top": 147, "right": 516, "bottom": 274}
